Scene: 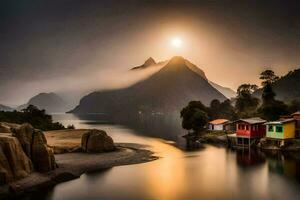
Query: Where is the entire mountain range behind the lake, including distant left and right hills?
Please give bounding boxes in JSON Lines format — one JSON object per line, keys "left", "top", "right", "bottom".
{"left": 0, "top": 56, "right": 300, "bottom": 113}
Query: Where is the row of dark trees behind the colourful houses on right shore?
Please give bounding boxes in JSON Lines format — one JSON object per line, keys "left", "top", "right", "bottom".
{"left": 181, "top": 70, "right": 300, "bottom": 132}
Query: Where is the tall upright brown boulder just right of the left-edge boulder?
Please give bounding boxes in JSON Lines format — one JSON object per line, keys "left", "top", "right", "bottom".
{"left": 12, "top": 124, "right": 56, "bottom": 172}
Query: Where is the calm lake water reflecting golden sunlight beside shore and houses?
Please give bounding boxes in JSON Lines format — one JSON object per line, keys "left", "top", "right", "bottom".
{"left": 32, "top": 115, "right": 300, "bottom": 200}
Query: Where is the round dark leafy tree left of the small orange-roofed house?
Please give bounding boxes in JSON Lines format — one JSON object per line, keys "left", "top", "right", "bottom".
{"left": 180, "top": 101, "right": 209, "bottom": 133}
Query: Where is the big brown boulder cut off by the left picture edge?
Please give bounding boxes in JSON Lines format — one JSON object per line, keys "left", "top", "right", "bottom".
{"left": 0, "top": 135, "right": 33, "bottom": 185}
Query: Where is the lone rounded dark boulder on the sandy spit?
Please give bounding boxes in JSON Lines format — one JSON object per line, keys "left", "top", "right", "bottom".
{"left": 81, "top": 129, "right": 116, "bottom": 153}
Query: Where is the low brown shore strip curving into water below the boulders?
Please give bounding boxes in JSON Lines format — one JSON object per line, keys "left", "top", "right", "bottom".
{"left": 0, "top": 143, "right": 158, "bottom": 199}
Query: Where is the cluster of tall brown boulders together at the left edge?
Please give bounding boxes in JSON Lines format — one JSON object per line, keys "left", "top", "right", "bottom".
{"left": 0, "top": 124, "right": 56, "bottom": 185}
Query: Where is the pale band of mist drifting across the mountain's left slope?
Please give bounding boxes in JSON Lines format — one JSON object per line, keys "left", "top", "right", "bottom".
{"left": 1, "top": 61, "right": 162, "bottom": 109}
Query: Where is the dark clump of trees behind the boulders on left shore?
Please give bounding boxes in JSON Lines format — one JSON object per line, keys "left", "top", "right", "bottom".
{"left": 0, "top": 105, "right": 65, "bottom": 131}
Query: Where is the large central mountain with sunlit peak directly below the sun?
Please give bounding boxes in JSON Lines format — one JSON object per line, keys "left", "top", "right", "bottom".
{"left": 70, "top": 57, "right": 226, "bottom": 115}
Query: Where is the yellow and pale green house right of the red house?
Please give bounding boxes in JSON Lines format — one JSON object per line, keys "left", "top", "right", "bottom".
{"left": 265, "top": 118, "right": 296, "bottom": 140}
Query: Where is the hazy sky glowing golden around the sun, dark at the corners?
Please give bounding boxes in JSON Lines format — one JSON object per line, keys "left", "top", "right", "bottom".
{"left": 0, "top": 0, "right": 300, "bottom": 105}
